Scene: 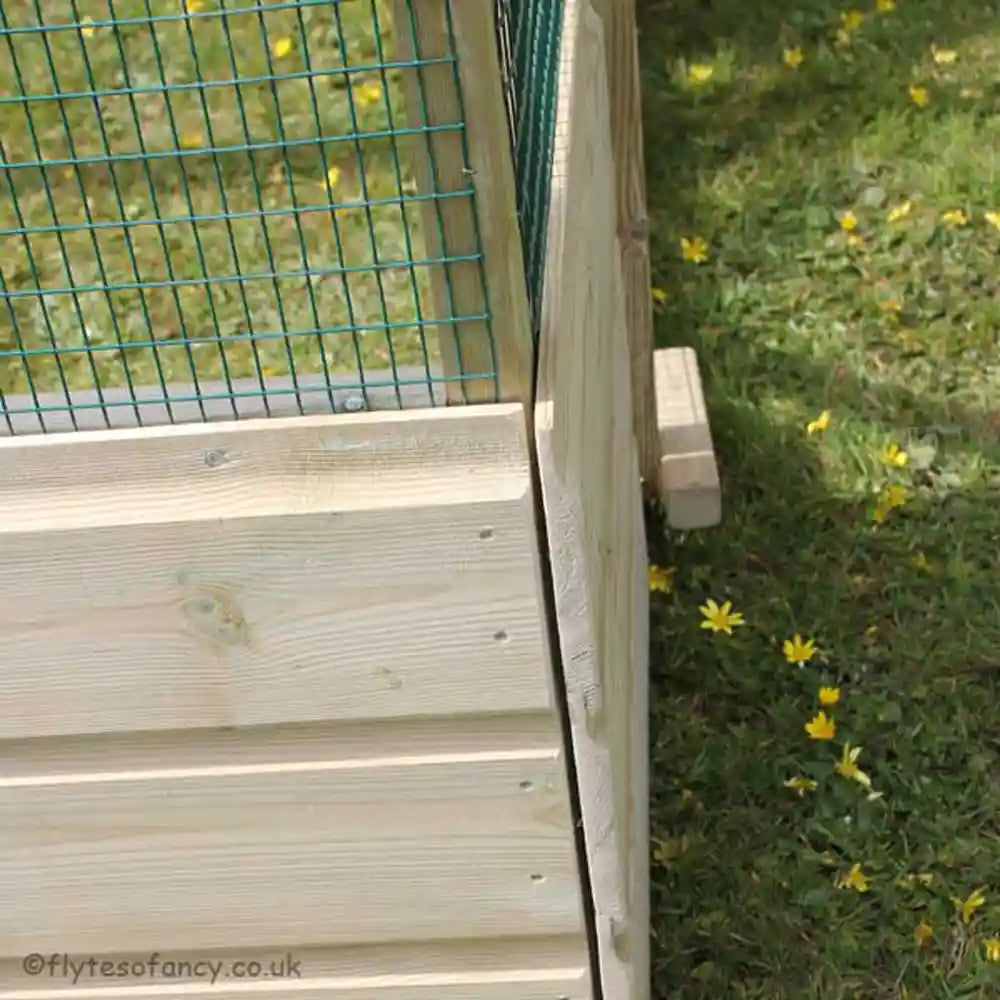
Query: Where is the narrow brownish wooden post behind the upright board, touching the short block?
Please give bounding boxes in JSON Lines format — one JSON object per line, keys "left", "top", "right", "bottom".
{"left": 593, "top": 0, "right": 660, "bottom": 496}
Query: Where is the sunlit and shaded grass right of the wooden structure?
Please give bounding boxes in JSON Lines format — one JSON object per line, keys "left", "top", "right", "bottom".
{"left": 640, "top": 0, "right": 1000, "bottom": 1000}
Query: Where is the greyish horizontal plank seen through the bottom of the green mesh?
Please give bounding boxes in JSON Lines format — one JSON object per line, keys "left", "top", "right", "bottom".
{"left": 0, "top": 367, "right": 445, "bottom": 437}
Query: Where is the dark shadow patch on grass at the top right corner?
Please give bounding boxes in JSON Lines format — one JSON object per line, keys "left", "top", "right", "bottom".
{"left": 638, "top": 0, "right": 1000, "bottom": 229}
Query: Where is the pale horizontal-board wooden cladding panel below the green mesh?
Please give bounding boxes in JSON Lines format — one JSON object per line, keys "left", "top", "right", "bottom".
{"left": 0, "top": 404, "right": 592, "bottom": 1000}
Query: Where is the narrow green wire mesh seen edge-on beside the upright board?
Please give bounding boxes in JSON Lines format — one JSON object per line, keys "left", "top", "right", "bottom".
{"left": 497, "top": 0, "right": 563, "bottom": 337}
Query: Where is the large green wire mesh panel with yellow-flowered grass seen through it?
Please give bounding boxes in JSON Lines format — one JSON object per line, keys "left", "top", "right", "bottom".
{"left": 0, "top": 0, "right": 492, "bottom": 434}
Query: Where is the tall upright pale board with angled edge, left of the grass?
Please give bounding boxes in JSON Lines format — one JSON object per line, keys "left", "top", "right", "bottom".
{"left": 535, "top": 0, "right": 650, "bottom": 1000}
